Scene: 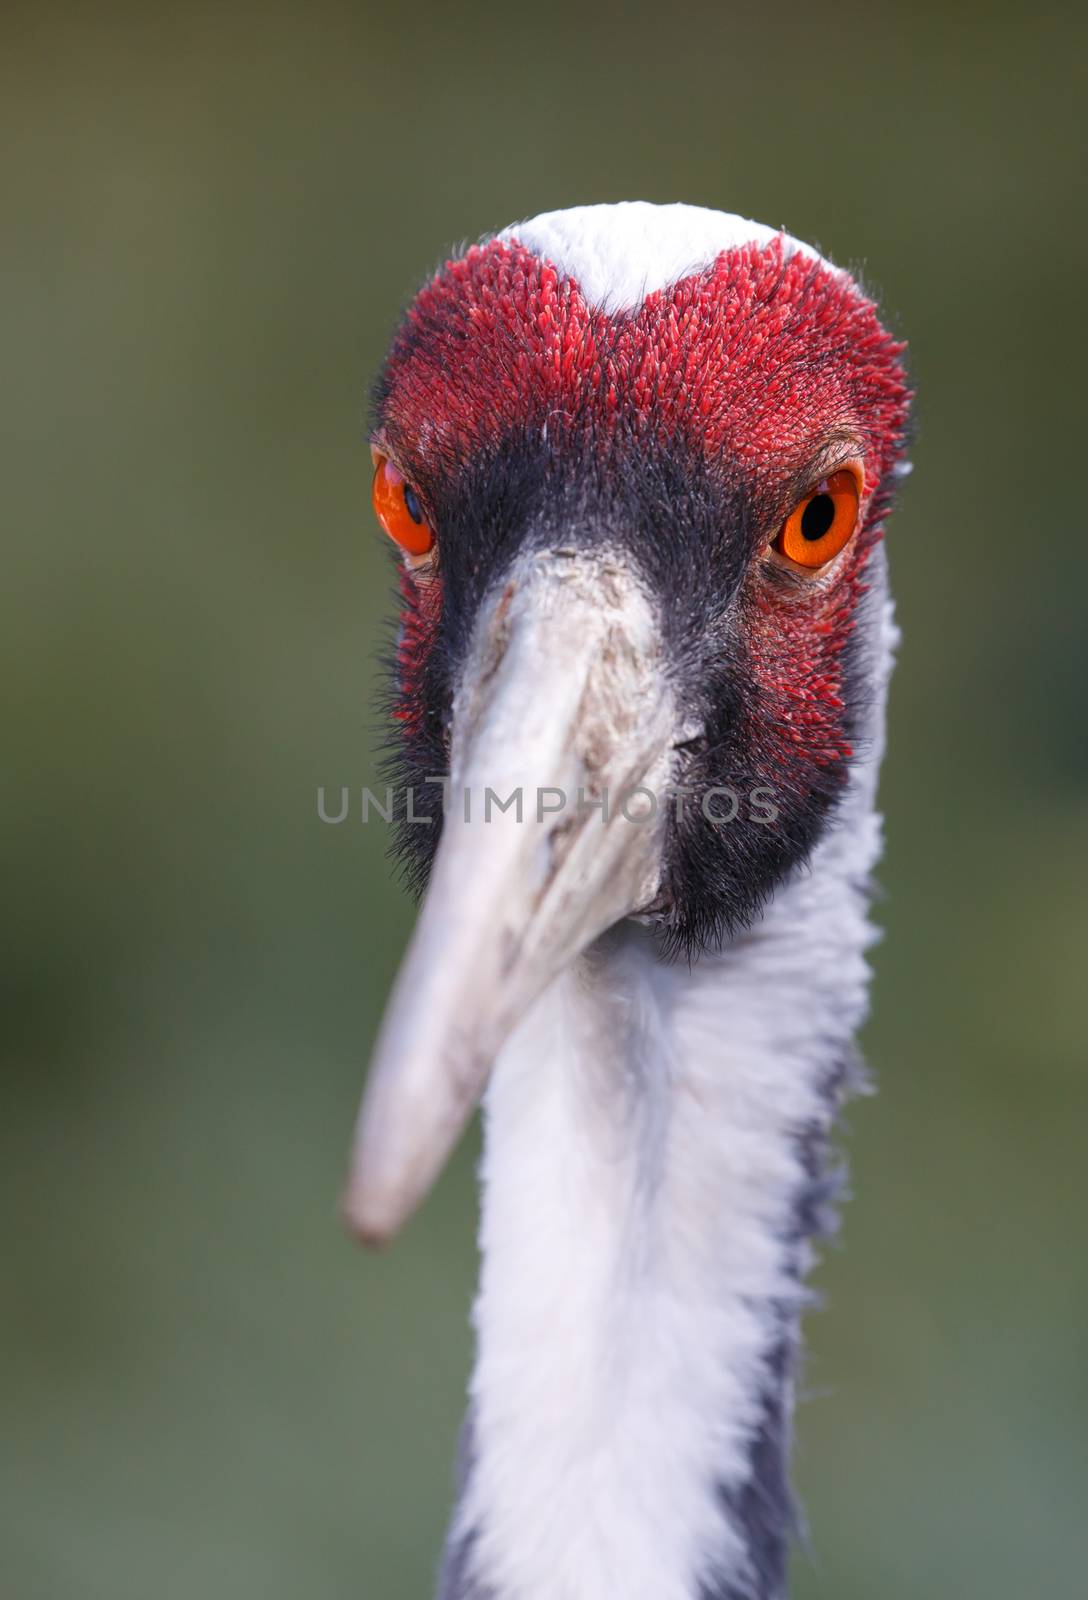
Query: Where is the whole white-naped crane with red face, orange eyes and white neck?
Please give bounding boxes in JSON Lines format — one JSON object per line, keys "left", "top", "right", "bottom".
{"left": 346, "top": 203, "right": 909, "bottom": 1600}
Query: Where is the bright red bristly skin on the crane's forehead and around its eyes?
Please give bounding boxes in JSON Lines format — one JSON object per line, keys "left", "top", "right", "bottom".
{"left": 378, "top": 238, "right": 909, "bottom": 766}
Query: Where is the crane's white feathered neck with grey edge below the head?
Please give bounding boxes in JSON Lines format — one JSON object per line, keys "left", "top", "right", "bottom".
{"left": 440, "top": 595, "right": 893, "bottom": 1600}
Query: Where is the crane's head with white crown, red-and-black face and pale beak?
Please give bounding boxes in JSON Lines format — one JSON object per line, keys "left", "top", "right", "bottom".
{"left": 347, "top": 205, "right": 907, "bottom": 1240}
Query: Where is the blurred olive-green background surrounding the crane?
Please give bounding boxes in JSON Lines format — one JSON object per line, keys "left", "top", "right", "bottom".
{"left": 0, "top": 0, "right": 1088, "bottom": 1600}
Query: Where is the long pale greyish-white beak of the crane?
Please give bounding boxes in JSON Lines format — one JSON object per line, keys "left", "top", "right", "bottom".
{"left": 344, "top": 550, "right": 674, "bottom": 1243}
